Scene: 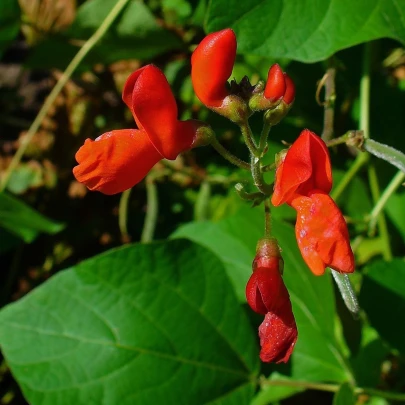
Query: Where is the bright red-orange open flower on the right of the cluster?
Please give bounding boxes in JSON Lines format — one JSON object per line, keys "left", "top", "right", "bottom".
{"left": 271, "top": 129, "right": 355, "bottom": 275}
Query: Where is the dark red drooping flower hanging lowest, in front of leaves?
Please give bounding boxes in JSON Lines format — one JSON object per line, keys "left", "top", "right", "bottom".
{"left": 246, "top": 239, "right": 298, "bottom": 363}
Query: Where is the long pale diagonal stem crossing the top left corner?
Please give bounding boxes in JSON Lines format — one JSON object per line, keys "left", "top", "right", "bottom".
{"left": 0, "top": 0, "right": 129, "bottom": 192}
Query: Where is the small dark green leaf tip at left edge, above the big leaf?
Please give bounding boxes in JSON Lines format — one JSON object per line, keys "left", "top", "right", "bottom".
{"left": 0, "top": 193, "right": 64, "bottom": 243}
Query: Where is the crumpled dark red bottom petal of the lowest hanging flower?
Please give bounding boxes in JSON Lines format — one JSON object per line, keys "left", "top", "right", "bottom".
{"left": 259, "top": 301, "right": 298, "bottom": 363}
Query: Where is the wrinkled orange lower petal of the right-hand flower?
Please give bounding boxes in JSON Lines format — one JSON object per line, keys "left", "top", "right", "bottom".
{"left": 291, "top": 191, "right": 355, "bottom": 275}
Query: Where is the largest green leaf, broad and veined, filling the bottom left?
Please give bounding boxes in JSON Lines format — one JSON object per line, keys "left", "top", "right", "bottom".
{"left": 0, "top": 240, "right": 259, "bottom": 405}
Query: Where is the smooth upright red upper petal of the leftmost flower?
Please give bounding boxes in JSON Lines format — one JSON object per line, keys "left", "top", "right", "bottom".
{"left": 123, "top": 65, "right": 196, "bottom": 159}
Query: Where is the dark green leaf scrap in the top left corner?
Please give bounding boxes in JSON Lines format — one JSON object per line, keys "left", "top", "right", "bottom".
{"left": 0, "top": 0, "right": 20, "bottom": 57}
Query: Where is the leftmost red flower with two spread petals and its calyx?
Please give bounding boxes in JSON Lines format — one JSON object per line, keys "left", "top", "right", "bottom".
{"left": 73, "top": 65, "right": 210, "bottom": 194}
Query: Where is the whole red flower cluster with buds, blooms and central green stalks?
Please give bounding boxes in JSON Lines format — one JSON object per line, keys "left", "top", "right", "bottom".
{"left": 73, "top": 29, "right": 354, "bottom": 363}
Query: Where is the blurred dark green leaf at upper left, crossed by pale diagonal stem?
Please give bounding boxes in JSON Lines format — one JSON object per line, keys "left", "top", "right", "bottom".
{"left": 27, "top": 0, "right": 182, "bottom": 68}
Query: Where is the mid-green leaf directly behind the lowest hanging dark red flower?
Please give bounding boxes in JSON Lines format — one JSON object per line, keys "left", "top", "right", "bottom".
{"left": 173, "top": 208, "right": 351, "bottom": 382}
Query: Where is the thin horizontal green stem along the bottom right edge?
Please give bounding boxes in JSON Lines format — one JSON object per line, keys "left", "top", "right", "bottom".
{"left": 260, "top": 380, "right": 405, "bottom": 402}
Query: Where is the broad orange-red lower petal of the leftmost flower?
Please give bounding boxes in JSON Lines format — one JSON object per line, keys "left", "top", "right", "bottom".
{"left": 73, "top": 129, "right": 162, "bottom": 194}
